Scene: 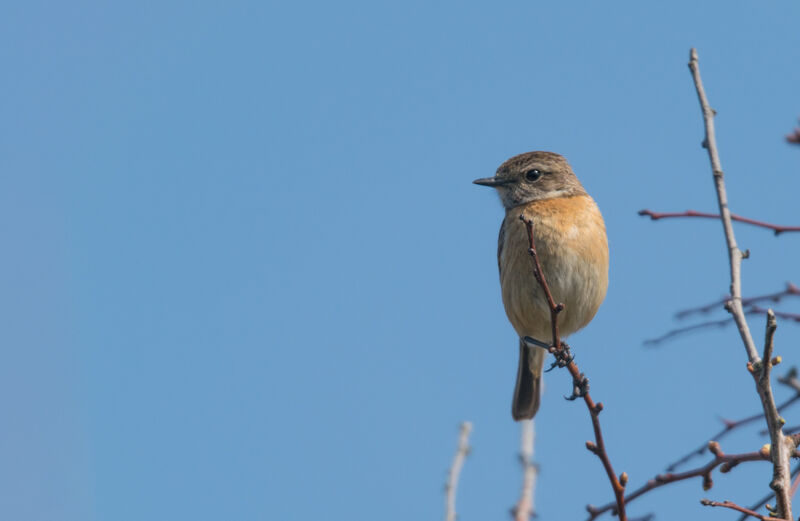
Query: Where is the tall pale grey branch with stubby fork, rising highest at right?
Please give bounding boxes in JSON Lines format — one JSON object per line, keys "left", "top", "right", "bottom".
{"left": 689, "top": 48, "right": 792, "bottom": 519}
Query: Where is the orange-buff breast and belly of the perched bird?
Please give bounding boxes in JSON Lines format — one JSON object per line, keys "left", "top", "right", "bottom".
{"left": 497, "top": 195, "right": 608, "bottom": 342}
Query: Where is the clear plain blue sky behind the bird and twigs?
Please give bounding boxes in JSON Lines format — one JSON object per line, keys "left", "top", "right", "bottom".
{"left": 0, "top": 1, "right": 800, "bottom": 521}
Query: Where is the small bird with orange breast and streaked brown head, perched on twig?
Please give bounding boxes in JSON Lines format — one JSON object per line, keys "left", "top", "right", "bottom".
{"left": 473, "top": 151, "right": 608, "bottom": 421}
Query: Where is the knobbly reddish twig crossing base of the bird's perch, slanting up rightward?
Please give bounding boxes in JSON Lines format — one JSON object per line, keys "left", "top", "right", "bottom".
{"left": 586, "top": 441, "right": 798, "bottom": 521}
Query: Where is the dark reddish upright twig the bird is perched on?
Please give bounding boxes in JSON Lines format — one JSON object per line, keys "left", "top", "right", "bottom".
{"left": 520, "top": 214, "right": 628, "bottom": 521}
